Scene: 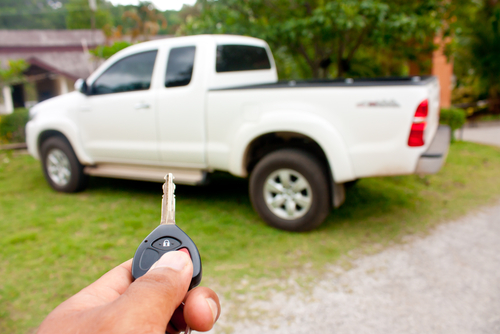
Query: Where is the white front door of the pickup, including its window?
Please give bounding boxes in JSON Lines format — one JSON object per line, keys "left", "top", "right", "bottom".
{"left": 78, "top": 50, "right": 159, "bottom": 163}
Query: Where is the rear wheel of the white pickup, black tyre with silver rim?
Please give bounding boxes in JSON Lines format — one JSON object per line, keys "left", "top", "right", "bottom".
{"left": 250, "top": 149, "right": 330, "bottom": 231}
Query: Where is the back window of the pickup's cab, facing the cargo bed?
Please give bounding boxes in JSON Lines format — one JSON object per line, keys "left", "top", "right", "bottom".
{"left": 215, "top": 45, "right": 271, "bottom": 72}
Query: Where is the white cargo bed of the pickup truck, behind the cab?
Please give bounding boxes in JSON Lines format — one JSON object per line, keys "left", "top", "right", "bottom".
{"left": 207, "top": 76, "right": 439, "bottom": 183}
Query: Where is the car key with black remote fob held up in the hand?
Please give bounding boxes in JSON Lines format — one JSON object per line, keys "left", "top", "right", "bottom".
{"left": 132, "top": 173, "right": 201, "bottom": 290}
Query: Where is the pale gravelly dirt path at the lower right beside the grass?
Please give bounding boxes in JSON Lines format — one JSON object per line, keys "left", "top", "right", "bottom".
{"left": 212, "top": 203, "right": 500, "bottom": 334}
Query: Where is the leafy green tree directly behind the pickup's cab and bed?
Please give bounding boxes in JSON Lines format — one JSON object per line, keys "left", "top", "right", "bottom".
{"left": 181, "top": 0, "right": 449, "bottom": 78}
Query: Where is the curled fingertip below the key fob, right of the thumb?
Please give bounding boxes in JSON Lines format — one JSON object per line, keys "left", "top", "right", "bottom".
{"left": 184, "top": 287, "right": 220, "bottom": 332}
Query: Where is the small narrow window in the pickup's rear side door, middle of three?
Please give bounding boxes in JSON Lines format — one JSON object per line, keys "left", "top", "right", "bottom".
{"left": 165, "top": 46, "right": 196, "bottom": 87}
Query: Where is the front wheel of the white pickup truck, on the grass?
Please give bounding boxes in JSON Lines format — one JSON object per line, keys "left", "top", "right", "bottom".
{"left": 41, "top": 137, "right": 88, "bottom": 193}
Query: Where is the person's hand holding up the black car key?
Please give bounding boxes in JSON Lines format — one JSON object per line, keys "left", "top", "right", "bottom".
{"left": 38, "top": 252, "right": 220, "bottom": 334}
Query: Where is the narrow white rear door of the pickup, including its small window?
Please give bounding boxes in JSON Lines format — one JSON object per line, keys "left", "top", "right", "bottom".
{"left": 158, "top": 45, "right": 204, "bottom": 168}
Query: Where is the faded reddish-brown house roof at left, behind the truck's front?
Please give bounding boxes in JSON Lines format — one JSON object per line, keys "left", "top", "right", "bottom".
{"left": 0, "top": 30, "right": 106, "bottom": 80}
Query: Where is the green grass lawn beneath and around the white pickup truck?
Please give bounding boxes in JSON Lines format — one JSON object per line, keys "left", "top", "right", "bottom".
{"left": 0, "top": 142, "right": 500, "bottom": 333}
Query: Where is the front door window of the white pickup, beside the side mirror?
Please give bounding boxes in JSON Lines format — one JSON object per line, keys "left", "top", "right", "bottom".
{"left": 90, "top": 50, "right": 158, "bottom": 95}
